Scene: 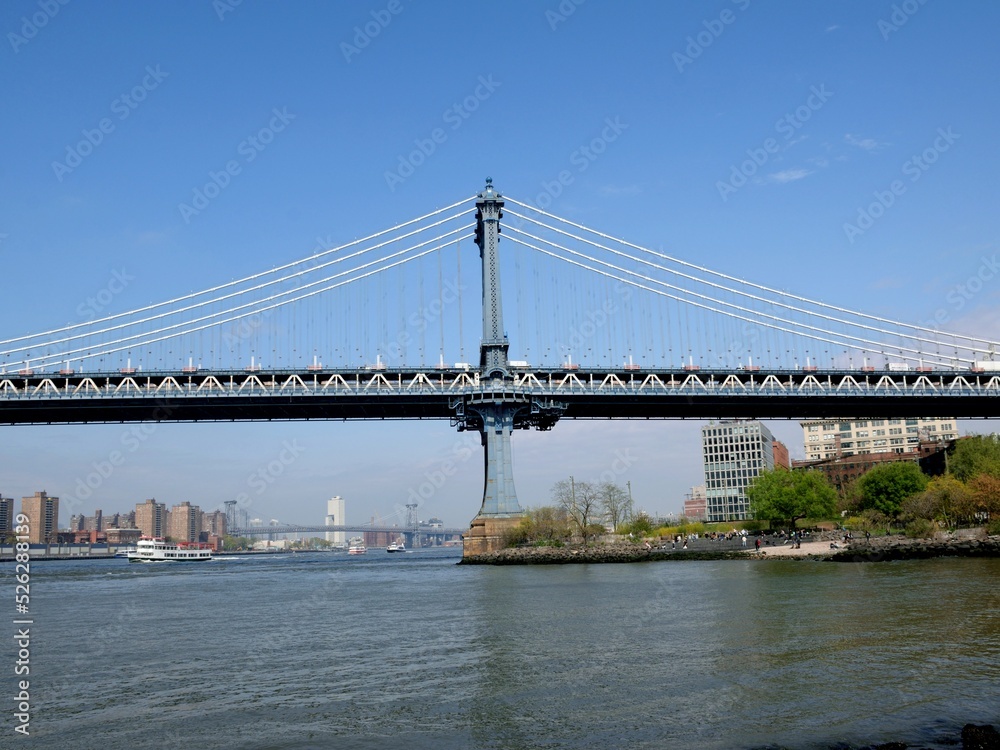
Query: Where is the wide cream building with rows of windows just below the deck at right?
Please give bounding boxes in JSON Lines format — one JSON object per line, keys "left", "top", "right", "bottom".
{"left": 799, "top": 417, "right": 958, "bottom": 461}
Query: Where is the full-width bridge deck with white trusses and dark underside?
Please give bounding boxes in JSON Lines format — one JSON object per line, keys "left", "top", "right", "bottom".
{"left": 0, "top": 367, "right": 1000, "bottom": 429}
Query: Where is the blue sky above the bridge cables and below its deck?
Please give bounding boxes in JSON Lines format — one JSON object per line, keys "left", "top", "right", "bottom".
{"left": 0, "top": 0, "right": 1000, "bottom": 525}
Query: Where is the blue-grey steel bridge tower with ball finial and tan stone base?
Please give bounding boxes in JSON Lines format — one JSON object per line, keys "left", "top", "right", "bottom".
{"left": 454, "top": 177, "right": 565, "bottom": 555}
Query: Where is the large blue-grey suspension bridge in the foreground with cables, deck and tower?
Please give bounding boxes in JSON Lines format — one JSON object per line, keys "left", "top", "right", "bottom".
{"left": 0, "top": 179, "right": 1000, "bottom": 553}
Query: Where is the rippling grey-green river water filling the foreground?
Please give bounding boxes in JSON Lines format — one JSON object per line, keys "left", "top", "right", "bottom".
{"left": 7, "top": 550, "right": 1000, "bottom": 750}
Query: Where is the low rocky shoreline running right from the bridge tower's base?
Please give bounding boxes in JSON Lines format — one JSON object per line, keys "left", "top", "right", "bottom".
{"left": 459, "top": 534, "right": 1000, "bottom": 565}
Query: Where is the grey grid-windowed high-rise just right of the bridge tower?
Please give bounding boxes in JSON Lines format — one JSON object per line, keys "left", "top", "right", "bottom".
{"left": 701, "top": 422, "right": 774, "bottom": 522}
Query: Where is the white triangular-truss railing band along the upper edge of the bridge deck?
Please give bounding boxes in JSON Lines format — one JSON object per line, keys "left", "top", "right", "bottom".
{"left": 0, "top": 370, "right": 1000, "bottom": 400}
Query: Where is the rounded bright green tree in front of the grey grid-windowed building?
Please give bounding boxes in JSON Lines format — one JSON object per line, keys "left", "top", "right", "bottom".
{"left": 747, "top": 470, "right": 837, "bottom": 528}
